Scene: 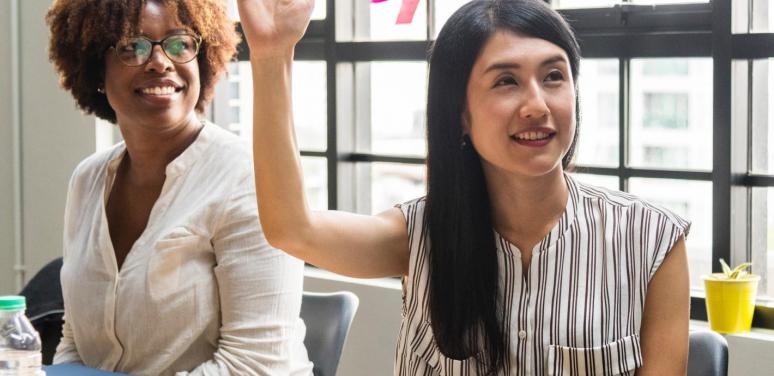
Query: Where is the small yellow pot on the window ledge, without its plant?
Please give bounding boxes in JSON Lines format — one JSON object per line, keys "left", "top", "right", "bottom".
{"left": 702, "top": 273, "right": 761, "bottom": 333}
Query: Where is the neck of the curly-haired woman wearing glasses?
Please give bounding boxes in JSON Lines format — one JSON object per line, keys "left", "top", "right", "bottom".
{"left": 119, "top": 116, "right": 202, "bottom": 184}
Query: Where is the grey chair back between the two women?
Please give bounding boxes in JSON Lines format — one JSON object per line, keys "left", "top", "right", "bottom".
{"left": 301, "top": 291, "right": 359, "bottom": 376}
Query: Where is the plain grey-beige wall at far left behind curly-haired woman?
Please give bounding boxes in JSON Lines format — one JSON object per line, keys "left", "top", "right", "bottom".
{"left": 0, "top": 0, "right": 95, "bottom": 293}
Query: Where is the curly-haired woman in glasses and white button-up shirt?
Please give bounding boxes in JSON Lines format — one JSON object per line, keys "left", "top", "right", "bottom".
{"left": 47, "top": 0, "right": 311, "bottom": 375}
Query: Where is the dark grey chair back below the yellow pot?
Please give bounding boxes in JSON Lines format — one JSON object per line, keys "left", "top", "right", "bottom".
{"left": 688, "top": 331, "right": 728, "bottom": 376}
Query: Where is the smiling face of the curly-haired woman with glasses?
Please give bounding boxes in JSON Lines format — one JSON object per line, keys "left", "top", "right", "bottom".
{"left": 105, "top": 1, "right": 200, "bottom": 131}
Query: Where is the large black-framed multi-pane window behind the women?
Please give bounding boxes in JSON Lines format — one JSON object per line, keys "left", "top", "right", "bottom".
{"left": 213, "top": 0, "right": 774, "bottom": 328}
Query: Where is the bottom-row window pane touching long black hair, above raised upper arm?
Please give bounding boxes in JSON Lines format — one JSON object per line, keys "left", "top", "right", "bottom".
{"left": 370, "top": 163, "right": 426, "bottom": 214}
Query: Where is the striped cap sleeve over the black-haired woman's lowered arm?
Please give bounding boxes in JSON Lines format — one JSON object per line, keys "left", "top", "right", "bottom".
{"left": 648, "top": 209, "right": 691, "bottom": 281}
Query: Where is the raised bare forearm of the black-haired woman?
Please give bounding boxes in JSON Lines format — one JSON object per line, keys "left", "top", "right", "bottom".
{"left": 251, "top": 53, "right": 310, "bottom": 254}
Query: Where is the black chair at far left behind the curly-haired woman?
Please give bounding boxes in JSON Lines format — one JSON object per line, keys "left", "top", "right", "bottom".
{"left": 19, "top": 257, "right": 64, "bottom": 365}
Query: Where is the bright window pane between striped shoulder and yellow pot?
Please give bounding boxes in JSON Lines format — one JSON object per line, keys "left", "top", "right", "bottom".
{"left": 629, "top": 178, "right": 712, "bottom": 289}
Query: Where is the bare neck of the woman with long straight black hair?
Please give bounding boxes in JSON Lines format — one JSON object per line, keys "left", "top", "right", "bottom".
{"left": 484, "top": 166, "right": 569, "bottom": 238}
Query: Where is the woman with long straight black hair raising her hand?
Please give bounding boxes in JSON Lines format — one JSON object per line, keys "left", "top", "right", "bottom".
{"left": 239, "top": 0, "right": 689, "bottom": 375}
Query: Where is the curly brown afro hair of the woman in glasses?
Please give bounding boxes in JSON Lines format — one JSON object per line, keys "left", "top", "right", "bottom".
{"left": 46, "top": 0, "right": 240, "bottom": 123}
